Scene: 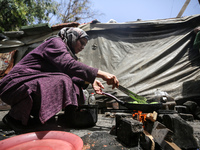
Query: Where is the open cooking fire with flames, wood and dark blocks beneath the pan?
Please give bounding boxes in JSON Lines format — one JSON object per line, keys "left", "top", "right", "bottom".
{"left": 110, "top": 99, "right": 200, "bottom": 150}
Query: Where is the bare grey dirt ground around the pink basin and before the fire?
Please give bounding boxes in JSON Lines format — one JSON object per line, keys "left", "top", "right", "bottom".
{"left": 0, "top": 111, "right": 140, "bottom": 150}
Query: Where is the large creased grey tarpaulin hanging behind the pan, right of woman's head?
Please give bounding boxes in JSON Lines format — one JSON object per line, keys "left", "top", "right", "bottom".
{"left": 79, "top": 15, "right": 200, "bottom": 100}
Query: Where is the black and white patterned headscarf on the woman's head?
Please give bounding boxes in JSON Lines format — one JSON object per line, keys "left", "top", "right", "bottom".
{"left": 58, "top": 27, "right": 89, "bottom": 60}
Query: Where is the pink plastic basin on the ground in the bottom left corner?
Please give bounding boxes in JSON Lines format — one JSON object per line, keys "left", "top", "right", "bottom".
{"left": 0, "top": 131, "right": 83, "bottom": 150}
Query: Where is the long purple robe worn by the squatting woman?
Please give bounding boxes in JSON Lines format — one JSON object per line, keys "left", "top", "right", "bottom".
{"left": 0, "top": 37, "right": 98, "bottom": 124}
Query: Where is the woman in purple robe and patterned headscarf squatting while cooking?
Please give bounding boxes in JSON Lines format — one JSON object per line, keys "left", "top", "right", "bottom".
{"left": 0, "top": 28, "right": 119, "bottom": 131}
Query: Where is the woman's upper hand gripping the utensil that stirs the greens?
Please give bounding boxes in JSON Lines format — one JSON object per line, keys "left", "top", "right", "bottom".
{"left": 97, "top": 70, "right": 119, "bottom": 89}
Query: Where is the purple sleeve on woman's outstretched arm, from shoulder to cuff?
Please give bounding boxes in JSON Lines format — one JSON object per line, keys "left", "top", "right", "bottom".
{"left": 43, "top": 38, "right": 98, "bottom": 83}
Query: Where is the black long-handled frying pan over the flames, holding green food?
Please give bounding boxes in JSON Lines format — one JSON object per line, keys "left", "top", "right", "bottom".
{"left": 103, "top": 92, "right": 162, "bottom": 113}
